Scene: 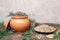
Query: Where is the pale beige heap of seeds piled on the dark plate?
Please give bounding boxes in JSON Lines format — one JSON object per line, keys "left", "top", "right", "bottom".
{"left": 34, "top": 24, "right": 56, "bottom": 32}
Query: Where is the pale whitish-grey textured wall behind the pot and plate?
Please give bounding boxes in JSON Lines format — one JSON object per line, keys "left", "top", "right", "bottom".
{"left": 0, "top": 0, "right": 60, "bottom": 23}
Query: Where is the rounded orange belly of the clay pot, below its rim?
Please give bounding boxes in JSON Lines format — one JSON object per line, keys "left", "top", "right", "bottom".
{"left": 10, "top": 19, "right": 30, "bottom": 32}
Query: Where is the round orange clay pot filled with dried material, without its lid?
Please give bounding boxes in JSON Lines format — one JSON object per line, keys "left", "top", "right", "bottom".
{"left": 10, "top": 16, "right": 30, "bottom": 32}
